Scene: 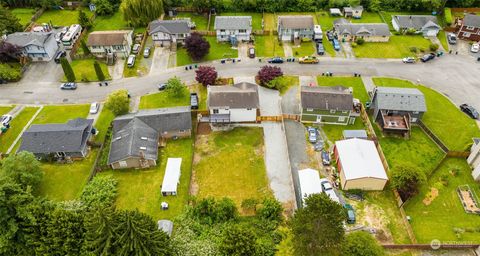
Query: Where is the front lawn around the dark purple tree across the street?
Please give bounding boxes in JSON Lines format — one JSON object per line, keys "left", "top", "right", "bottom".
{"left": 177, "top": 36, "right": 238, "bottom": 66}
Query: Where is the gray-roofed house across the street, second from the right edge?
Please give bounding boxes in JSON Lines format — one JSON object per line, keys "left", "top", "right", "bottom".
{"left": 392, "top": 15, "right": 442, "bottom": 36}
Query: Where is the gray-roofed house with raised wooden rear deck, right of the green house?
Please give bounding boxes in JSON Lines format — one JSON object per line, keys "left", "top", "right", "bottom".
{"left": 370, "top": 87, "right": 427, "bottom": 135}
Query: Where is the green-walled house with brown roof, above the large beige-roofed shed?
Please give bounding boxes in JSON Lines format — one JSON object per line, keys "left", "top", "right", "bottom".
{"left": 300, "top": 86, "right": 355, "bottom": 125}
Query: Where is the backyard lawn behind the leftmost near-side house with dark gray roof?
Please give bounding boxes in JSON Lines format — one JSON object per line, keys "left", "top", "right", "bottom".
{"left": 38, "top": 150, "right": 98, "bottom": 201}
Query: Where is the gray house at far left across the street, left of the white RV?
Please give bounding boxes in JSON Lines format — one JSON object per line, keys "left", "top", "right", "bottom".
{"left": 5, "top": 32, "right": 58, "bottom": 61}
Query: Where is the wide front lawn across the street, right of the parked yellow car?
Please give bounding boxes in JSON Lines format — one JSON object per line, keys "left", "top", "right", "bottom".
{"left": 353, "top": 36, "right": 431, "bottom": 58}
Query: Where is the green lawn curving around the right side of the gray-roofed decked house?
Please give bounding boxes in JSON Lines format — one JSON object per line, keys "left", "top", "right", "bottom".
{"left": 373, "top": 78, "right": 480, "bottom": 151}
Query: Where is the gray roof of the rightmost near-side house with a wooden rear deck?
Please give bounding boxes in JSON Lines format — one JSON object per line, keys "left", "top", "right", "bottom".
{"left": 374, "top": 87, "right": 427, "bottom": 112}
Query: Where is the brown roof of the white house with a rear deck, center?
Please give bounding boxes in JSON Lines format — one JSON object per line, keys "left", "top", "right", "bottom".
{"left": 208, "top": 82, "right": 259, "bottom": 108}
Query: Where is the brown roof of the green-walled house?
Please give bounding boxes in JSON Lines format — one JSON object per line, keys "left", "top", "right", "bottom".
{"left": 301, "top": 86, "right": 353, "bottom": 110}
